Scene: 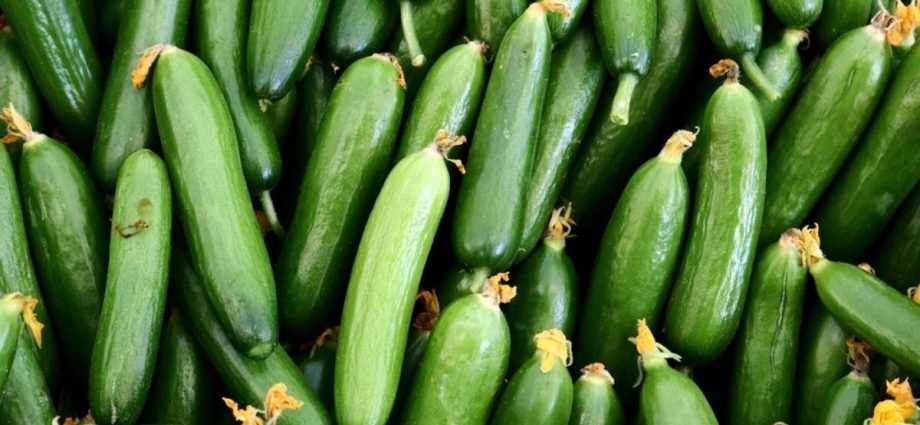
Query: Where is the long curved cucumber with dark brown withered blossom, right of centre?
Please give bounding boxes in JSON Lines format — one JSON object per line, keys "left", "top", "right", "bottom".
{"left": 664, "top": 60, "right": 767, "bottom": 366}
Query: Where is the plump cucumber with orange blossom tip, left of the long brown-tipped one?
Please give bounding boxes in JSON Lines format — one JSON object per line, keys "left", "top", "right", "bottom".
{"left": 575, "top": 131, "right": 694, "bottom": 404}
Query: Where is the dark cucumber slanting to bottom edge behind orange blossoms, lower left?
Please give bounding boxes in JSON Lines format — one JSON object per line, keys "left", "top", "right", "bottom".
{"left": 170, "top": 240, "right": 332, "bottom": 425}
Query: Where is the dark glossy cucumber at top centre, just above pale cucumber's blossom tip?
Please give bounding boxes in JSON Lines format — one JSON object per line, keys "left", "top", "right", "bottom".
{"left": 453, "top": 2, "right": 554, "bottom": 270}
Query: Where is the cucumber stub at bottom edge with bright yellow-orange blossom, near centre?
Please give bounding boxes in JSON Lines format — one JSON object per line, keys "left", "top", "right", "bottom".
{"left": 491, "top": 329, "right": 574, "bottom": 425}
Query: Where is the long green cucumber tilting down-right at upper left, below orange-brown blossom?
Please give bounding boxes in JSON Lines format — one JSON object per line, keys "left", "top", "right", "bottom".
{"left": 153, "top": 48, "right": 278, "bottom": 357}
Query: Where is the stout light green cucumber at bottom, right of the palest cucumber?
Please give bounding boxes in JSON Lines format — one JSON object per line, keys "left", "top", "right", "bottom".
{"left": 401, "top": 275, "right": 516, "bottom": 424}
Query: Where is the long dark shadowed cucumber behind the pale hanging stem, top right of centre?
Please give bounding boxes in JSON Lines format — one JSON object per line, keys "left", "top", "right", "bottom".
{"left": 561, "top": 0, "right": 700, "bottom": 232}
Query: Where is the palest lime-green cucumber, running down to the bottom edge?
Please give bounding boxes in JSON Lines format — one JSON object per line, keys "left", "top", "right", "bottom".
{"left": 336, "top": 137, "right": 452, "bottom": 425}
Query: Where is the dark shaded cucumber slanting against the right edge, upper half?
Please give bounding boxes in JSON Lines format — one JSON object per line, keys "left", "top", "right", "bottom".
{"left": 814, "top": 43, "right": 920, "bottom": 262}
